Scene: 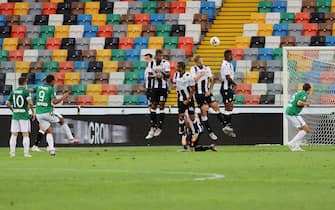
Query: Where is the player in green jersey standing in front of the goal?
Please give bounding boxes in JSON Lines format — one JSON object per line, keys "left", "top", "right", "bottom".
{"left": 285, "top": 83, "right": 311, "bottom": 151}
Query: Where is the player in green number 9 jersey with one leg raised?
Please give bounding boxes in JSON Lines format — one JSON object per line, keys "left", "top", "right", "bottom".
{"left": 32, "top": 75, "right": 79, "bottom": 155}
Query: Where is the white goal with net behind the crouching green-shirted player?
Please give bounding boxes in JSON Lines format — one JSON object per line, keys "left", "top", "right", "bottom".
{"left": 283, "top": 47, "right": 335, "bottom": 145}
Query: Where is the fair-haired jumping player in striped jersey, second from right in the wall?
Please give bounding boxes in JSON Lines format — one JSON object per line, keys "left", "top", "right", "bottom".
{"left": 190, "top": 56, "right": 228, "bottom": 141}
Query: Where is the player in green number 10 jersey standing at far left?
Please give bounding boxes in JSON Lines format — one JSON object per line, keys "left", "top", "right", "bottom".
{"left": 6, "top": 77, "right": 35, "bottom": 157}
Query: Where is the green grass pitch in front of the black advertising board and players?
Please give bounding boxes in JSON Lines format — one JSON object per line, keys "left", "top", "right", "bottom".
{"left": 0, "top": 146, "right": 335, "bottom": 210}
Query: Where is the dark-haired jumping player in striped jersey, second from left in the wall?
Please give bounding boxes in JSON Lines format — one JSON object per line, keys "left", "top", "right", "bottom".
{"left": 145, "top": 50, "right": 170, "bottom": 140}
